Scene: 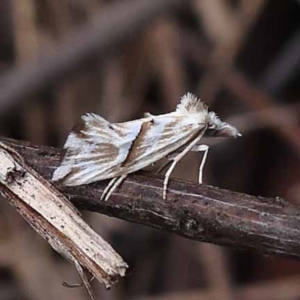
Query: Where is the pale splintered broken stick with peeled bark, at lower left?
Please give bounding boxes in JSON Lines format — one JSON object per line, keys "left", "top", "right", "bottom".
{"left": 0, "top": 143, "right": 127, "bottom": 287}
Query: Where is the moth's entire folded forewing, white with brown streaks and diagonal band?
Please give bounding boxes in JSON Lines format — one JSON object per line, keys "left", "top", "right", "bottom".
{"left": 52, "top": 113, "right": 204, "bottom": 179}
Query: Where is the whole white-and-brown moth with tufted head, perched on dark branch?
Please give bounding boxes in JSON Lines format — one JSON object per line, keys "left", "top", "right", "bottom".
{"left": 52, "top": 93, "right": 241, "bottom": 200}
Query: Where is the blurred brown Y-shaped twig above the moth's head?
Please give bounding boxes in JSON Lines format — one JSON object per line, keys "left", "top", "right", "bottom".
{"left": 196, "top": 0, "right": 266, "bottom": 105}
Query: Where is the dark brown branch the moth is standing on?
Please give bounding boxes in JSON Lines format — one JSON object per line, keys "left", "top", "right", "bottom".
{"left": 0, "top": 138, "right": 300, "bottom": 259}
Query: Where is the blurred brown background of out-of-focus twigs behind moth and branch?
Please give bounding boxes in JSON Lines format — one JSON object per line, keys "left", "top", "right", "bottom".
{"left": 0, "top": 0, "right": 300, "bottom": 300}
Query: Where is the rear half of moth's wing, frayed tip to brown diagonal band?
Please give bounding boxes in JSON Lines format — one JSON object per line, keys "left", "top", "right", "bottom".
{"left": 52, "top": 114, "right": 143, "bottom": 185}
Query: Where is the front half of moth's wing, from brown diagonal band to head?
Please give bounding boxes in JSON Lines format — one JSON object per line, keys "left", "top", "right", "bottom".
{"left": 124, "top": 113, "right": 206, "bottom": 173}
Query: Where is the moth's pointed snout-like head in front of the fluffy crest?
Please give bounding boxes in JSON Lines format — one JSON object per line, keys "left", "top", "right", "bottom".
{"left": 205, "top": 111, "right": 242, "bottom": 138}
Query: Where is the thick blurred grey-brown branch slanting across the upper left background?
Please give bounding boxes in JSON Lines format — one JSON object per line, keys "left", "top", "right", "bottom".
{"left": 0, "top": 0, "right": 184, "bottom": 114}
